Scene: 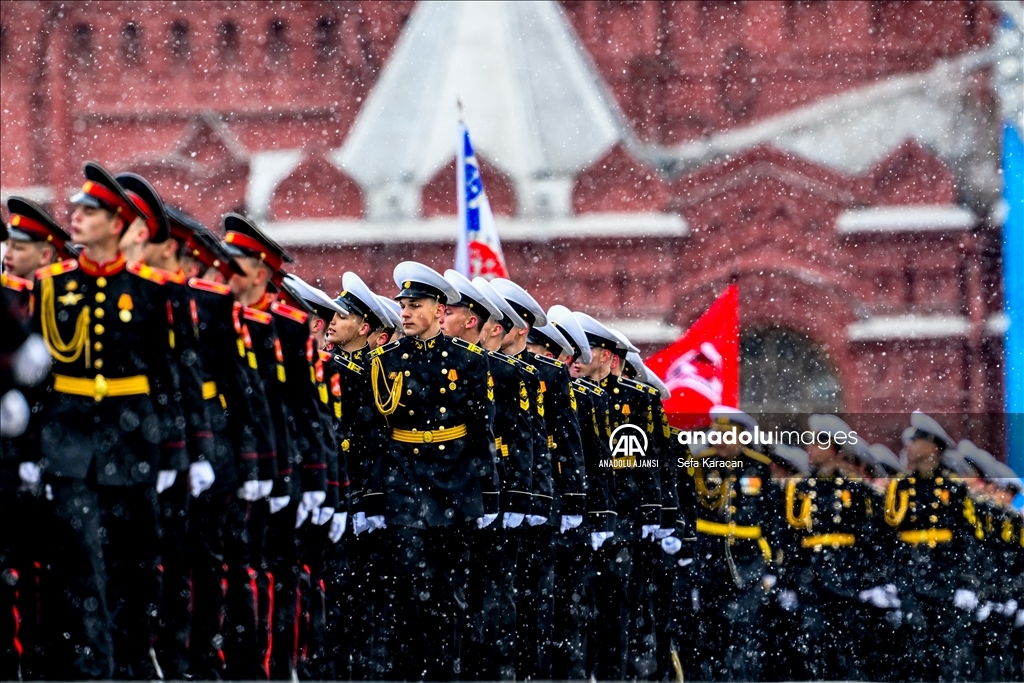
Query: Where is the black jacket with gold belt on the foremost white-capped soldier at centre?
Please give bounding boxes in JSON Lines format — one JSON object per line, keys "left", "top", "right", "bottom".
{"left": 364, "top": 333, "right": 498, "bottom": 528}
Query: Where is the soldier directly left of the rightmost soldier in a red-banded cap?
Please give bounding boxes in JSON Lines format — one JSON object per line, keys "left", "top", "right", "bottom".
{"left": 167, "top": 207, "right": 276, "bottom": 680}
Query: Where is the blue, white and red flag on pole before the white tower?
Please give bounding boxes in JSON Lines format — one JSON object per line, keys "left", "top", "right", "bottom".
{"left": 455, "top": 121, "right": 508, "bottom": 280}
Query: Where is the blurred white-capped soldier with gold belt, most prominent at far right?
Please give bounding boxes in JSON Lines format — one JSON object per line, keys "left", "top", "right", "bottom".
{"left": 885, "top": 413, "right": 984, "bottom": 681}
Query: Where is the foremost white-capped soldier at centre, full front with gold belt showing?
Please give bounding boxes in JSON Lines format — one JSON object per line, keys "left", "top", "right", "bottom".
{"left": 364, "top": 262, "right": 497, "bottom": 680}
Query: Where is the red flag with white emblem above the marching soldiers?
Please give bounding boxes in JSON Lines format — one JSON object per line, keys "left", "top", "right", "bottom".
{"left": 646, "top": 285, "right": 739, "bottom": 429}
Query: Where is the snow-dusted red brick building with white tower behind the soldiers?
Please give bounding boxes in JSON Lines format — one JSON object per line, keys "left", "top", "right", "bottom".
{"left": 0, "top": 0, "right": 1002, "bottom": 447}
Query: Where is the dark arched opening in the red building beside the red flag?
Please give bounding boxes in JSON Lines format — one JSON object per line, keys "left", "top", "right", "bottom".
{"left": 739, "top": 328, "right": 843, "bottom": 416}
